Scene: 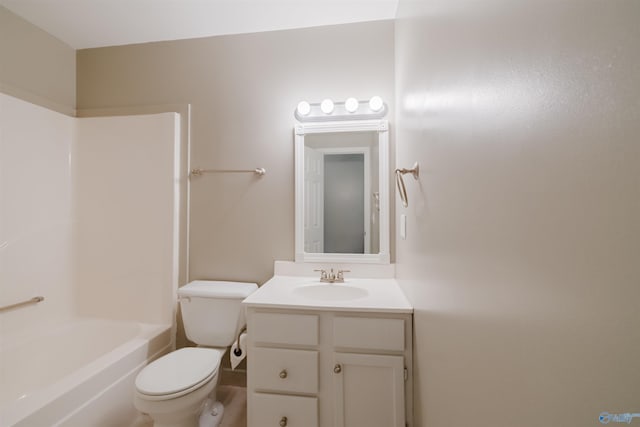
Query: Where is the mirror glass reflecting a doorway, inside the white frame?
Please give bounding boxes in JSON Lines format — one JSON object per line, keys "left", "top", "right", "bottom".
{"left": 304, "top": 132, "right": 380, "bottom": 254}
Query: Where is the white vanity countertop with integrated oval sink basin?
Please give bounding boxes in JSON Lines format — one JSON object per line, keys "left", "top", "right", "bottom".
{"left": 242, "top": 275, "right": 413, "bottom": 313}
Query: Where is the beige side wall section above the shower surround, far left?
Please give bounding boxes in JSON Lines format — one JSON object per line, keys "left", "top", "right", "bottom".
{"left": 0, "top": 6, "right": 76, "bottom": 115}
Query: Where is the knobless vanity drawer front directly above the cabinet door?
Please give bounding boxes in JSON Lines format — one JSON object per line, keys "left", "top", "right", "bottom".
{"left": 333, "top": 317, "right": 404, "bottom": 351}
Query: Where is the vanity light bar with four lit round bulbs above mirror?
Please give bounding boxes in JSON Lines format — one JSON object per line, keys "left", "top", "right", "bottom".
{"left": 294, "top": 95, "right": 388, "bottom": 122}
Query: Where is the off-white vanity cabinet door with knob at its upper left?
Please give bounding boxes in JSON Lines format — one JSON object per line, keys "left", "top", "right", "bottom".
{"left": 334, "top": 353, "right": 405, "bottom": 427}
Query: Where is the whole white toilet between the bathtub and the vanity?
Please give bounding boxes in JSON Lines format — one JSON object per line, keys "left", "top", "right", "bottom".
{"left": 134, "top": 281, "right": 258, "bottom": 427}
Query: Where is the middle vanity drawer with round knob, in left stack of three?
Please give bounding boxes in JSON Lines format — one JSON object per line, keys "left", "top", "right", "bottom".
{"left": 247, "top": 347, "right": 318, "bottom": 393}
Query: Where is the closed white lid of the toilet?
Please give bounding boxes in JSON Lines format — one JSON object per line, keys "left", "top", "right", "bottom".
{"left": 136, "top": 347, "right": 223, "bottom": 396}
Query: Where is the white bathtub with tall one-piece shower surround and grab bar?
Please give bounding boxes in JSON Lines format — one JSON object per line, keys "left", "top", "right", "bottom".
{"left": 0, "top": 94, "right": 185, "bottom": 427}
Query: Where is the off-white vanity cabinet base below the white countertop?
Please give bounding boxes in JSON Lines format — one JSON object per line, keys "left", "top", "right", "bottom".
{"left": 247, "top": 307, "right": 413, "bottom": 427}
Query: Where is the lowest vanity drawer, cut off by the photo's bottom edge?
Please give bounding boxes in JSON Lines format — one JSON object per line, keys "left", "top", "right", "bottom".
{"left": 249, "top": 393, "right": 318, "bottom": 427}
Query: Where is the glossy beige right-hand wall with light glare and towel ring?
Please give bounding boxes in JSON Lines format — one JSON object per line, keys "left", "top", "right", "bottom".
{"left": 396, "top": 0, "right": 640, "bottom": 427}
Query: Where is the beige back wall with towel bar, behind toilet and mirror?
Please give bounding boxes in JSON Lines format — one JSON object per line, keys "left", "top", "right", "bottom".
{"left": 77, "top": 21, "right": 394, "bottom": 283}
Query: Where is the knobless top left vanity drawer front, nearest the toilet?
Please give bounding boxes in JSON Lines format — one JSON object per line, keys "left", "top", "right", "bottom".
{"left": 248, "top": 313, "right": 318, "bottom": 346}
